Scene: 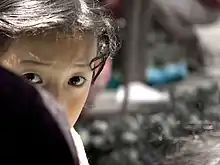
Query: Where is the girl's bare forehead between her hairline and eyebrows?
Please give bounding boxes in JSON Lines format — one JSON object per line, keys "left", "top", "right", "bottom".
{"left": 8, "top": 33, "right": 97, "bottom": 63}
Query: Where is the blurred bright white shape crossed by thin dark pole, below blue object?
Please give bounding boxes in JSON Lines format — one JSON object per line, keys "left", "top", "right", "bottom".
{"left": 116, "top": 82, "right": 169, "bottom": 103}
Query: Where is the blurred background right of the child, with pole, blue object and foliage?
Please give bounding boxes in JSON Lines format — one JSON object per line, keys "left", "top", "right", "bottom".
{"left": 76, "top": 0, "right": 220, "bottom": 165}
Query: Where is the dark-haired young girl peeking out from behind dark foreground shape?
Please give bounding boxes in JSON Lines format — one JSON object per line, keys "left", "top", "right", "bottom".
{"left": 0, "top": 0, "right": 117, "bottom": 165}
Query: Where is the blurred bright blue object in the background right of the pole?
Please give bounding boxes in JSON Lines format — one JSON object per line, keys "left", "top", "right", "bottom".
{"left": 146, "top": 61, "right": 189, "bottom": 85}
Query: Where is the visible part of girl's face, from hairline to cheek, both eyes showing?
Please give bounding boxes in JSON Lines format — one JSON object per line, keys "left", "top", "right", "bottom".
{"left": 0, "top": 33, "right": 97, "bottom": 125}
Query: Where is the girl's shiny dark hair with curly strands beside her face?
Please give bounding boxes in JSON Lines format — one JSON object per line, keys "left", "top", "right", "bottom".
{"left": 0, "top": 0, "right": 117, "bottom": 82}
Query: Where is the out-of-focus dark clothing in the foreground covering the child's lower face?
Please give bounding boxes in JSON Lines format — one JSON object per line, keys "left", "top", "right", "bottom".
{"left": 0, "top": 68, "right": 78, "bottom": 165}
